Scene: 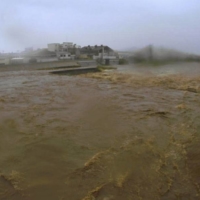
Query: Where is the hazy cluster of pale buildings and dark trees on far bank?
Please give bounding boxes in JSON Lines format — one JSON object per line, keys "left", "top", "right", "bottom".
{"left": 0, "top": 42, "right": 118, "bottom": 65}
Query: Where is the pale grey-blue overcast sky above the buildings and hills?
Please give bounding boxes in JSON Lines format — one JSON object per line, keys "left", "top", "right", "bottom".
{"left": 0, "top": 0, "right": 200, "bottom": 54}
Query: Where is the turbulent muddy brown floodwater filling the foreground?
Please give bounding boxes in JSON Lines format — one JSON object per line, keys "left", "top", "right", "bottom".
{"left": 0, "top": 63, "right": 200, "bottom": 200}
